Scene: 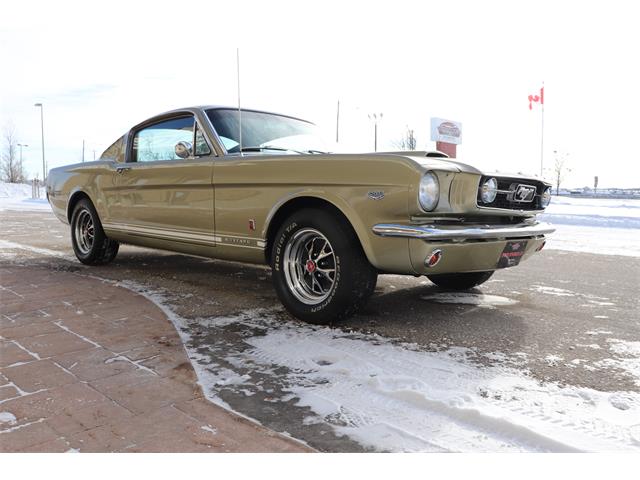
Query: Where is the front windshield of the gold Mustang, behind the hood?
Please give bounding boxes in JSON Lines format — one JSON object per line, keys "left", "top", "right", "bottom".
{"left": 206, "top": 109, "right": 327, "bottom": 154}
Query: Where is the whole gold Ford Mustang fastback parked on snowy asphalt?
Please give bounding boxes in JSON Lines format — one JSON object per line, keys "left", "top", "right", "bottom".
{"left": 47, "top": 106, "right": 553, "bottom": 323}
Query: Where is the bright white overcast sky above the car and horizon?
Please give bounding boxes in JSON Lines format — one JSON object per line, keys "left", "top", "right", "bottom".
{"left": 0, "top": 0, "right": 640, "bottom": 187}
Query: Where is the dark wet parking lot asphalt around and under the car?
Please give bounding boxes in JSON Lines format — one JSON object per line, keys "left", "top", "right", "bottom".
{"left": 0, "top": 211, "right": 640, "bottom": 451}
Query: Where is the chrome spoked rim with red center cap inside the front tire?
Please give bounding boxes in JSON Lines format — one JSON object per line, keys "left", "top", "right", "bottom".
{"left": 283, "top": 228, "right": 336, "bottom": 305}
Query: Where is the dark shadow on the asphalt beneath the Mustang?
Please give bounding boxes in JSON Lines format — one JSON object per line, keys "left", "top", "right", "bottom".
{"left": 82, "top": 249, "right": 530, "bottom": 351}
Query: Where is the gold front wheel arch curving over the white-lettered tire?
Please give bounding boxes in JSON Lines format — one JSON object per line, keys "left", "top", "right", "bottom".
{"left": 263, "top": 192, "right": 373, "bottom": 264}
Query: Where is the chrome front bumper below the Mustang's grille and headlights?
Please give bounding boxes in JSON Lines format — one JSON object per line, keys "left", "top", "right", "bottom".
{"left": 372, "top": 223, "right": 555, "bottom": 242}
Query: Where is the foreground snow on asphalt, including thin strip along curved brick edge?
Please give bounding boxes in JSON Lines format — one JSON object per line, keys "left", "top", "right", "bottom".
{"left": 112, "top": 282, "right": 640, "bottom": 452}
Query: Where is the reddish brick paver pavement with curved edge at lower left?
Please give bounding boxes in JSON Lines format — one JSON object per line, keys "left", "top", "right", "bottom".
{"left": 0, "top": 265, "right": 310, "bottom": 452}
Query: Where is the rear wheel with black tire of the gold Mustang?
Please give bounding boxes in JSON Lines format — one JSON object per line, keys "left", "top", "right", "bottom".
{"left": 71, "top": 198, "right": 120, "bottom": 265}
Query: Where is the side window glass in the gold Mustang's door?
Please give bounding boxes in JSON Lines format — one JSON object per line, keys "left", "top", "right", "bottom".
{"left": 132, "top": 115, "right": 195, "bottom": 162}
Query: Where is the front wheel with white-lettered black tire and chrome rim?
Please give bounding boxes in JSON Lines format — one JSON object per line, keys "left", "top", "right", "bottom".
{"left": 271, "top": 209, "right": 378, "bottom": 324}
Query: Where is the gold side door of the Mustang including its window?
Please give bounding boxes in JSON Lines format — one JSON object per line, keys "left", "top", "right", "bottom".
{"left": 105, "top": 113, "right": 215, "bottom": 246}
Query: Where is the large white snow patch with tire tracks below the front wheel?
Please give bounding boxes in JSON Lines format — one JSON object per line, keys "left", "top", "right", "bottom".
{"left": 242, "top": 327, "right": 640, "bottom": 451}
